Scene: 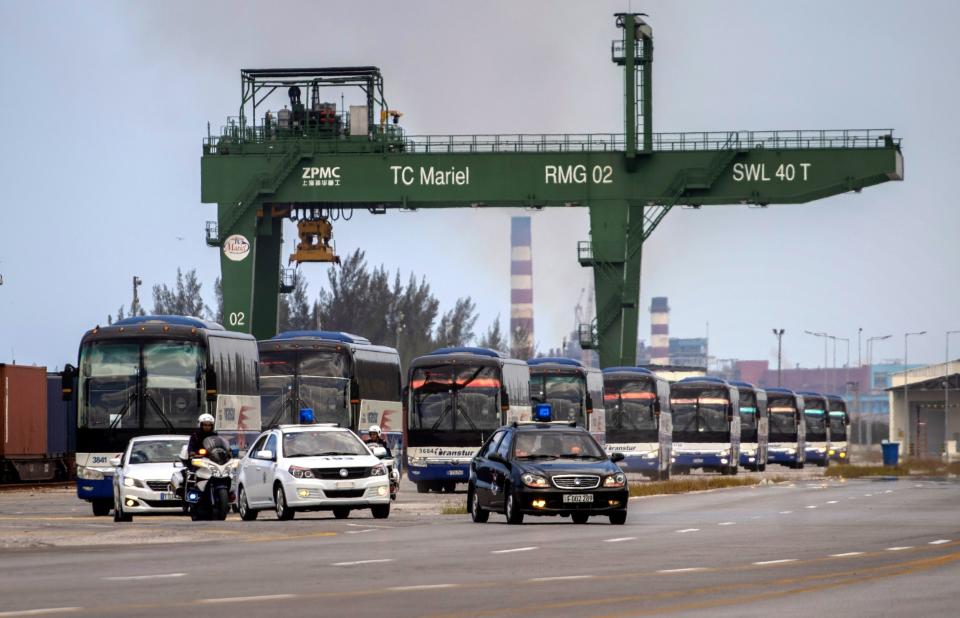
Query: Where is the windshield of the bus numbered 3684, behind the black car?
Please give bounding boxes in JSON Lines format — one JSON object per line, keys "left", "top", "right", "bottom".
{"left": 408, "top": 365, "right": 502, "bottom": 434}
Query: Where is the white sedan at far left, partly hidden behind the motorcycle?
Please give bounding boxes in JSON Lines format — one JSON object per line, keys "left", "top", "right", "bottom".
{"left": 110, "top": 436, "right": 189, "bottom": 521}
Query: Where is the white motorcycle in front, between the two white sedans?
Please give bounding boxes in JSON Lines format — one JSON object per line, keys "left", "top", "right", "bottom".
{"left": 170, "top": 436, "right": 240, "bottom": 521}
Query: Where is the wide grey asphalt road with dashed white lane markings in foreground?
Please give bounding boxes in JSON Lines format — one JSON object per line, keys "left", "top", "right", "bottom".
{"left": 0, "top": 479, "right": 960, "bottom": 616}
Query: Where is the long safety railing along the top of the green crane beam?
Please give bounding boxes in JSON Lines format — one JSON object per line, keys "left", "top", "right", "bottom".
{"left": 204, "top": 125, "right": 900, "bottom": 154}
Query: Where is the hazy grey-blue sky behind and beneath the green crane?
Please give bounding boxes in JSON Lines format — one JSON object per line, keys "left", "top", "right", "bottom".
{"left": 0, "top": 1, "right": 960, "bottom": 367}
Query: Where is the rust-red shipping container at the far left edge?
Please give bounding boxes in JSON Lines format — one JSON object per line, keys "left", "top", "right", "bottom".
{"left": 0, "top": 363, "right": 47, "bottom": 459}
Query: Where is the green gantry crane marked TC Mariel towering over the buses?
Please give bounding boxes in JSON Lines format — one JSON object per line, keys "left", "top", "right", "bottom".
{"left": 201, "top": 13, "right": 903, "bottom": 367}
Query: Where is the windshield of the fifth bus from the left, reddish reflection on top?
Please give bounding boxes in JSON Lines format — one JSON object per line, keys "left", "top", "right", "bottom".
{"left": 603, "top": 379, "right": 659, "bottom": 443}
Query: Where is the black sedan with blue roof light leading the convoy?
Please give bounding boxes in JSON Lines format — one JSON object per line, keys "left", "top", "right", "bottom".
{"left": 467, "top": 423, "right": 629, "bottom": 524}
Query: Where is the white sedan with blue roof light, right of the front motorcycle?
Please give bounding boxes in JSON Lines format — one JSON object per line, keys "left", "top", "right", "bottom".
{"left": 237, "top": 424, "right": 390, "bottom": 521}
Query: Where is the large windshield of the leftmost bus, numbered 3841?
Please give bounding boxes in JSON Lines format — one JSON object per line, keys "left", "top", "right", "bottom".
{"left": 78, "top": 340, "right": 203, "bottom": 429}
